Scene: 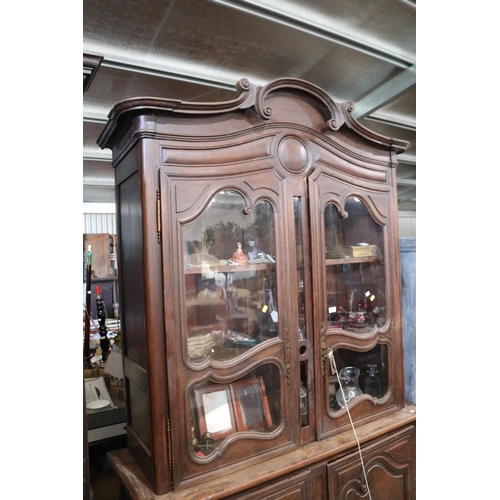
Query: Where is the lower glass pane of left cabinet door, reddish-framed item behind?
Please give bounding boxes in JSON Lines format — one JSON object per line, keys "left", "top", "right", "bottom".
{"left": 190, "top": 363, "right": 282, "bottom": 458}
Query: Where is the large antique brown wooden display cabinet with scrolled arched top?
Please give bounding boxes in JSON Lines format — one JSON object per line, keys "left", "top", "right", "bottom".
{"left": 98, "top": 78, "right": 415, "bottom": 500}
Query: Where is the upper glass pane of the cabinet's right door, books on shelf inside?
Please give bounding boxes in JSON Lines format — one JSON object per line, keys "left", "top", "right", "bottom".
{"left": 325, "top": 197, "right": 386, "bottom": 333}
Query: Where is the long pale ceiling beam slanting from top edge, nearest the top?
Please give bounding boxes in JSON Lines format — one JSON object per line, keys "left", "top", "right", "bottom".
{"left": 209, "top": 0, "right": 414, "bottom": 68}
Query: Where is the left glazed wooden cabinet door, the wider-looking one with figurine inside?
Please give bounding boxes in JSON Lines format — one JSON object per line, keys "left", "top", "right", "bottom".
{"left": 160, "top": 167, "right": 299, "bottom": 487}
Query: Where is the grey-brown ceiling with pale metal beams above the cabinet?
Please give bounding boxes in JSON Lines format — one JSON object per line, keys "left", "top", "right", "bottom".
{"left": 83, "top": 0, "right": 416, "bottom": 212}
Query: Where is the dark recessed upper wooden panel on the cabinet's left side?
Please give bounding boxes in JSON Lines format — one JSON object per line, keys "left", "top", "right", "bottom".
{"left": 118, "top": 173, "right": 147, "bottom": 368}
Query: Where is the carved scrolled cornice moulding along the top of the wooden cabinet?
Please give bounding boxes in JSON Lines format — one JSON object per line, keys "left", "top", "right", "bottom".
{"left": 96, "top": 78, "right": 410, "bottom": 154}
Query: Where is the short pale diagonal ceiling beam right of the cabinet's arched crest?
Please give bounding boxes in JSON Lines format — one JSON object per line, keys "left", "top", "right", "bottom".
{"left": 352, "top": 64, "right": 417, "bottom": 120}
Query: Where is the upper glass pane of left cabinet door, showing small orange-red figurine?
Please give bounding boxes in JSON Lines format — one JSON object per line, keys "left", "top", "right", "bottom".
{"left": 183, "top": 190, "right": 278, "bottom": 363}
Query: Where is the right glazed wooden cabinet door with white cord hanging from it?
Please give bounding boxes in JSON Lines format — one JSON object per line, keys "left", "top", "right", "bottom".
{"left": 310, "top": 173, "right": 403, "bottom": 437}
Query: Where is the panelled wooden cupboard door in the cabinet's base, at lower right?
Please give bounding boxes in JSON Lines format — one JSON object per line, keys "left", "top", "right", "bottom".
{"left": 328, "top": 426, "right": 415, "bottom": 500}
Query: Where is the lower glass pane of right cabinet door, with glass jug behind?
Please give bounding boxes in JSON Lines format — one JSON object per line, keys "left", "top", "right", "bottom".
{"left": 328, "top": 344, "right": 389, "bottom": 412}
